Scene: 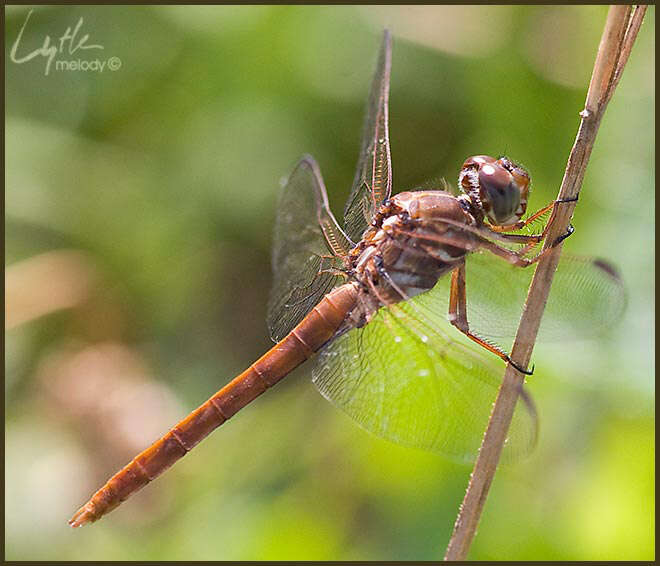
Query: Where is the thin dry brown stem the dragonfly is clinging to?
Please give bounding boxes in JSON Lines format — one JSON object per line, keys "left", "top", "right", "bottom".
{"left": 445, "top": 6, "right": 646, "bottom": 560}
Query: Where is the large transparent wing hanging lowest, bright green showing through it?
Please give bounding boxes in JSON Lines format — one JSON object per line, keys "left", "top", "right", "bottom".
{"left": 313, "top": 291, "right": 537, "bottom": 461}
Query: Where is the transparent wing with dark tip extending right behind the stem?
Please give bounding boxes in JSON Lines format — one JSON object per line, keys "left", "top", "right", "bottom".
{"left": 420, "top": 252, "right": 626, "bottom": 350}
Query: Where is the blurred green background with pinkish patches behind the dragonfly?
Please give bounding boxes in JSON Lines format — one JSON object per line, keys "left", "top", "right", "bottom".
{"left": 5, "top": 6, "right": 655, "bottom": 560}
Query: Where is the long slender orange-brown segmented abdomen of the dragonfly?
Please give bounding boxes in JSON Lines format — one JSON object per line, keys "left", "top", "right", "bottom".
{"left": 69, "top": 283, "right": 357, "bottom": 527}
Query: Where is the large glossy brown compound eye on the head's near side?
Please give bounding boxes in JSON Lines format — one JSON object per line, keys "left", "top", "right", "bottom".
{"left": 479, "top": 163, "right": 521, "bottom": 226}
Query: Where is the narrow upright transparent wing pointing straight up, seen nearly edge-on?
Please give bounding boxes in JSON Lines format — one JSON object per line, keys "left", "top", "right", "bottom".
{"left": 344, "top": 30, "right": 392, "bottom": 242}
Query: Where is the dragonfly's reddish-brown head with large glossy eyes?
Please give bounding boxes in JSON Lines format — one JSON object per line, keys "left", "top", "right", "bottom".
{"left": 458, "top": 155, "right": 530, "bottom": 226}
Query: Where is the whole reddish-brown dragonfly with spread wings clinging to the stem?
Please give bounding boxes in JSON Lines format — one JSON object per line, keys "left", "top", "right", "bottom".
{"left": 69, "top": 31, "right": 625, "bottom": 527}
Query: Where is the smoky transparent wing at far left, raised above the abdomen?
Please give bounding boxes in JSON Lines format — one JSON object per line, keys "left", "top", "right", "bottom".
{"left": 267, "top": 156, "right": 350, "bottom": 342}
